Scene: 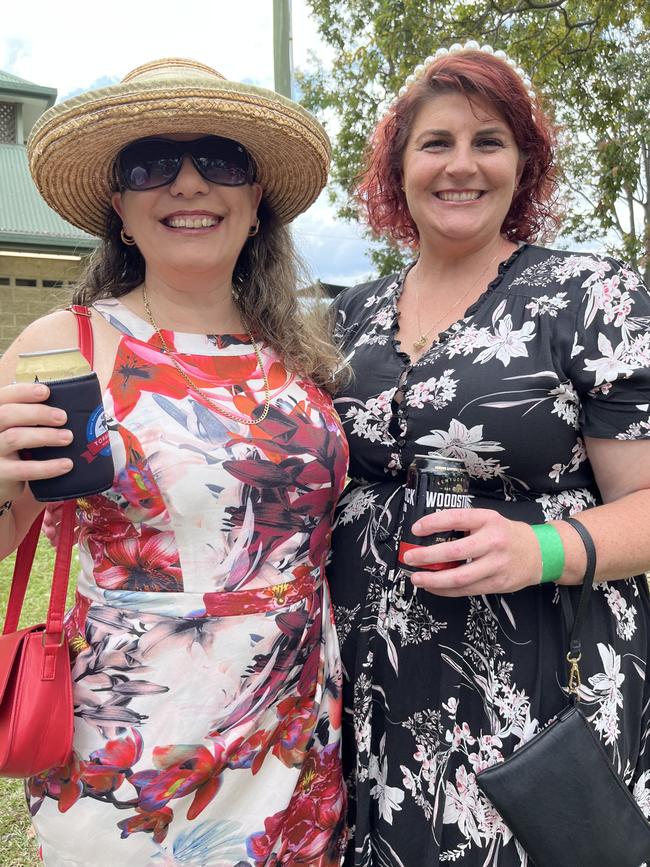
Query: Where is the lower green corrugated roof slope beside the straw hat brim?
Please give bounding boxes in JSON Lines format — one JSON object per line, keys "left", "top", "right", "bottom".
{"left": 0, "top": 144, "right": 97, "bottom": 250}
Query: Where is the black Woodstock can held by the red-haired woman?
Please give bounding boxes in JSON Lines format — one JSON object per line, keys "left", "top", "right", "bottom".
{"left": 397, "top": 455, "right": 472, "bottom": 575}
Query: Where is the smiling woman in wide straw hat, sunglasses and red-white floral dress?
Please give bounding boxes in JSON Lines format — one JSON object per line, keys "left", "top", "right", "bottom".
{"left": 0, "top": 59, "right": 347, "bottom": 867}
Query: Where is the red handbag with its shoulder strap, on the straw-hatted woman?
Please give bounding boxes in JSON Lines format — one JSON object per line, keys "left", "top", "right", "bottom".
{"left": 0, "top": 308, "right": 93, "bottom": 777}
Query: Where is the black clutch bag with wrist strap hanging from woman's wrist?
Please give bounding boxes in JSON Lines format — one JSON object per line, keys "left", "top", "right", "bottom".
{"left": 477, "top": 518, "right": 650, "bottom": 867}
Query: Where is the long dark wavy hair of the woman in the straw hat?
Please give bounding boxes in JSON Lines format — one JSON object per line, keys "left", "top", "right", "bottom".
{"left": 73, "top": 198, "right": 345, "bottom": 391}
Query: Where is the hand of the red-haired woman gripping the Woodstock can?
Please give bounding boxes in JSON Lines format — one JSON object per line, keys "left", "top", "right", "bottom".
{"left": 405, "top": 509, "right": 542, "bottom": 596}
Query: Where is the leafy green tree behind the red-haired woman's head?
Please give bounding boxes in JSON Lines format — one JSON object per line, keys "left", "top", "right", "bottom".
{"left": 300, "top": 0, "right": 650, "bottom": 282}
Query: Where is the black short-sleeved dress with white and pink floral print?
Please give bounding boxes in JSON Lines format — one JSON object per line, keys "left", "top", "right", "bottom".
{"left": 328, "top": 245, "right": 650, "bottom": 867}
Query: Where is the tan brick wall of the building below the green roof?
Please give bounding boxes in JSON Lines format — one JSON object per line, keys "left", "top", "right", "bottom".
{"left": 0, "top": 255, "right": 88, "bottom": 353}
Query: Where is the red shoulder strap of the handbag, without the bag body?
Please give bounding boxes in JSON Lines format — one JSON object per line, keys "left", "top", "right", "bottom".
{"left": 2, "top": 304, "right": 93, "bottom": 644}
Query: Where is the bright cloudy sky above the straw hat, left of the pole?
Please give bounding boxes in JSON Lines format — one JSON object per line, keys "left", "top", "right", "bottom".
{"left": 0, "top": 0, "right": 273, "bottom": 95}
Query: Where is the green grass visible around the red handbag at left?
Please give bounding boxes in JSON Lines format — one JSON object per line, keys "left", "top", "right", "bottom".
{"left": 0, "top": 539, "right": 76, "bottom": 867}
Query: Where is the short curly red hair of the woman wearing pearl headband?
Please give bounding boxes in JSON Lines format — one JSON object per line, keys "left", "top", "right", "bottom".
{"left": 356, "top": 50, "right": 558, "bottom": 246}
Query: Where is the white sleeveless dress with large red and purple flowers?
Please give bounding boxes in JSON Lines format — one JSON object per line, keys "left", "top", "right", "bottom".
{"left": 27, "top": 299, "right": 347, "bottom": 867}
